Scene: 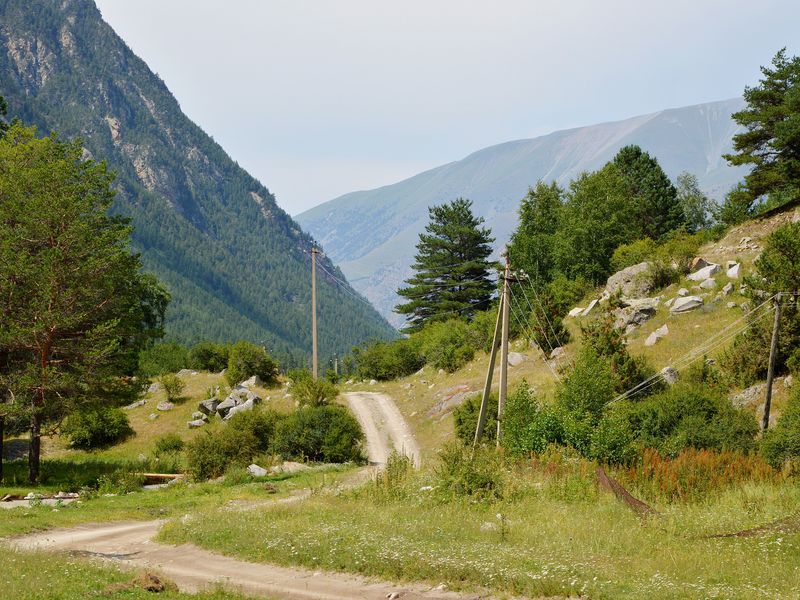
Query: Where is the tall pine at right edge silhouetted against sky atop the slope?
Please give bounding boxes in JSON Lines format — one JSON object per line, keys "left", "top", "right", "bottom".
{"left": 725, "top": 48, "right": 800, "bottom": 212}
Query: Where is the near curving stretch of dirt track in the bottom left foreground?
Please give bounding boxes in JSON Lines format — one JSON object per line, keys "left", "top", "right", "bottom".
{"left": 10, "top": 521, "right": 465, "bottom": 600}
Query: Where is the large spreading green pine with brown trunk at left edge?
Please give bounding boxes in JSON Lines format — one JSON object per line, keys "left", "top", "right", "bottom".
{"left": 0, "top": 123, "right": 169, "bottom": 482}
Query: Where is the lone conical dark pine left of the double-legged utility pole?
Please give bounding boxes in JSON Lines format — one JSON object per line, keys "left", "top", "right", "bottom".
{"left": 395, "top": 198, "right": 494, "bottom": 333}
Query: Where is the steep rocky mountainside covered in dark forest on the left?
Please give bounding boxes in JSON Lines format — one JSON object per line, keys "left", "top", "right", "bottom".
{"left": 0, "top": 0, "right": 393, "bottom": 364}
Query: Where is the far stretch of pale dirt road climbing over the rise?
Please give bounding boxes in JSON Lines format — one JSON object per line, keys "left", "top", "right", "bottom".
{"left": 344, "top": 392, "right": 421, "bottom": 468}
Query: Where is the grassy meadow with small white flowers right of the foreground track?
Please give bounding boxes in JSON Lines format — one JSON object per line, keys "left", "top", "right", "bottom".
{"left": 162, "top": 462, "right": 800, "bottom": 599}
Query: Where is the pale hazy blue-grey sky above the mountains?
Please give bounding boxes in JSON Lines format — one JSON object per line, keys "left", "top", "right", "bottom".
{"left": 96, "top": 0, "right": 800, "bottom": 215}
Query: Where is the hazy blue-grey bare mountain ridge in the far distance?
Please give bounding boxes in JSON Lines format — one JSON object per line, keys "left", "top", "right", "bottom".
{"left": 295, "top": 98, "right": 745, "bottom": 326}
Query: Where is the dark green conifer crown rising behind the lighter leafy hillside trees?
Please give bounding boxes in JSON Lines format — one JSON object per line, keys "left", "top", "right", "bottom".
{"left": 612, "top": 146, "right": 686, "bottom": 240}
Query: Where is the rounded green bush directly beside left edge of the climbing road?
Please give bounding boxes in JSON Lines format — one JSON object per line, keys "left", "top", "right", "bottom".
{"left": 270, "top": 405, "right": 364, "bottom": 463}
